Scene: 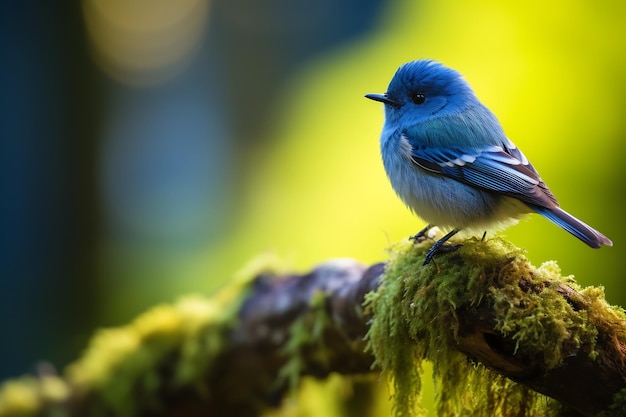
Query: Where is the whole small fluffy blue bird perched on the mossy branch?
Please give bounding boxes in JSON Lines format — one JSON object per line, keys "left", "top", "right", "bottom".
{"left": 365, "top": 60, "right": 613, "bottom": 264}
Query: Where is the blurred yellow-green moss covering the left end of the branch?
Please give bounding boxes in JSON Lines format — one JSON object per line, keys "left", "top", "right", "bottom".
{"left": 0, "top": 278, "right": 251, "bottom": 417}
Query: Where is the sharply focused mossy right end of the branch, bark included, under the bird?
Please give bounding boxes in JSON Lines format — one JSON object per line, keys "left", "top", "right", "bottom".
{"left": 368, "top": 239, "right": 626, "bottom": 416}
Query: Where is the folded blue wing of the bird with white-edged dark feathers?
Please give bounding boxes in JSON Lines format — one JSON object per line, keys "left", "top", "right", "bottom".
{"left": 403, "top": 136, "right": 558, "bottom": 208}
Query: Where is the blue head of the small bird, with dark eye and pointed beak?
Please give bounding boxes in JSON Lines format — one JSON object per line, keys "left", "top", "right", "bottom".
{"left": 365, "top": 60, "right": 477, "bottom": 124}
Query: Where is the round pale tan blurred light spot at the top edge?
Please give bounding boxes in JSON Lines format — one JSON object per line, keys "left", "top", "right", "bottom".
{"left": 82, "top": 0, "right": 209, "bottom": 85}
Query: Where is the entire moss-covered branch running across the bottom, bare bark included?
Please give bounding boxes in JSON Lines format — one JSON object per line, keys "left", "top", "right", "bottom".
{"left": 0, "top": 239, "right": 626, "bottom": 417}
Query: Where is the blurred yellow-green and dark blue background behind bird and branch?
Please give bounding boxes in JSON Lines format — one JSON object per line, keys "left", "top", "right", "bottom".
{"left": 0, "top": 0, "right": 626, "bottom": 408}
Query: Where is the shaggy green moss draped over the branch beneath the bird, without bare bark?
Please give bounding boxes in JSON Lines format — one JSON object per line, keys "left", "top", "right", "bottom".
{"left": 367, "top": 239, "right": 625, "bottom": 417}
